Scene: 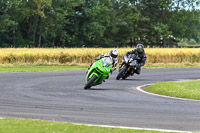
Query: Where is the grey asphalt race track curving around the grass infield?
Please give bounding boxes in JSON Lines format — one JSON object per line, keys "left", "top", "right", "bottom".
{"left": 0, "top": 68, "right": 200, "bottom": 131}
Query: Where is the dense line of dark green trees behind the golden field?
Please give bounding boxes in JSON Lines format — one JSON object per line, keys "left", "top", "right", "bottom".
{"left": 0, "top": 0, "right": 200, "bottom": 47}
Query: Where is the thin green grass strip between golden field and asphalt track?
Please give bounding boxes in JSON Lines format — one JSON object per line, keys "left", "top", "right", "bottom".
{"left": 0, "top": 65, "right": 200, "bottom": 72}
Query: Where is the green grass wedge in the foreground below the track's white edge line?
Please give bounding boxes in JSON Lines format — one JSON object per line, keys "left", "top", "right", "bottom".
{"left": 0, "top": 118, "right": 178, "bottom": 133}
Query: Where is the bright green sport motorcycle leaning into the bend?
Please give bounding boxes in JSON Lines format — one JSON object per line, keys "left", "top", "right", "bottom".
{"left": 84, "top": 57, "right": 113, "bottom": 89}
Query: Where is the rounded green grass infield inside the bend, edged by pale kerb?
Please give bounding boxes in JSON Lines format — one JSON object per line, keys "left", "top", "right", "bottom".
{"left": 144, "top": 80, "right": 200, "bottom": 100}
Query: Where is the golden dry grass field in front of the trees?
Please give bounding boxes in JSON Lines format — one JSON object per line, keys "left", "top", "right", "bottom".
{"left": 0, "top": 48, "right": 200, "bottom": 65}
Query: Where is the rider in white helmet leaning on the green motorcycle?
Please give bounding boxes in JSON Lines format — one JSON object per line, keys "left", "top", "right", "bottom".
{"left": 86, "top": 49, "right": 118, "bottom": 76}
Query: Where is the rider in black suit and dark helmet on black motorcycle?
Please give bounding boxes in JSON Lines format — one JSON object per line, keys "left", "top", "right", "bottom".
{"left": 119, "top": 44, "right": 147, "bottom": 75}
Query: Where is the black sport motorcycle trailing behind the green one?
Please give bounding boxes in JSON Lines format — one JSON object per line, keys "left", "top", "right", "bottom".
{"left": 116, "top": 54, "right": 138, "bottom": 80}
